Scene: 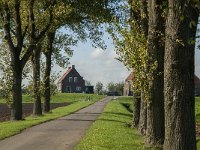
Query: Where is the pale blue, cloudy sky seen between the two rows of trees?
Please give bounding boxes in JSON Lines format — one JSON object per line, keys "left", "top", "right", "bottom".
{"left": 54, "top": 29, "right": 200, "bottom": 88}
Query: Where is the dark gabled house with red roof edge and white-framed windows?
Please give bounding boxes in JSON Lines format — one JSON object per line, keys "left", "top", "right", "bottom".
{"left": 58, "top": 65, "right": 94, "bottom": 93}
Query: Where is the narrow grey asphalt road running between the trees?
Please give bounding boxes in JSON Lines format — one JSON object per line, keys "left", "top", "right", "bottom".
{"left": 0, "top": 97, "right": 112, "bottom": 150}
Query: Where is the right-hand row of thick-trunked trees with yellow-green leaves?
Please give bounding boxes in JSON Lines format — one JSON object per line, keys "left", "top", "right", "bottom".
{"left": 109, "top": 0, "right": 200, "bottom": 150}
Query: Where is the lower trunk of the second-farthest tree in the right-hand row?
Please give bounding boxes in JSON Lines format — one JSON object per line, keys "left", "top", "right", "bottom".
{"left": 139, "top": 92, "right": 147, "bottom": 135}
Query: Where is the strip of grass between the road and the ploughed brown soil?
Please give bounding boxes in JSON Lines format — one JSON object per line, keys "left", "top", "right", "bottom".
{"left": 0, "top": 100, "right": 101, "bottom": 140}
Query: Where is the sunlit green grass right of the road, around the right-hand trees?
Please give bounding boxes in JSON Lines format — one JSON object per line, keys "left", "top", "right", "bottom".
{"left": 75, "top": 98, "right": 200, "bottom": 150}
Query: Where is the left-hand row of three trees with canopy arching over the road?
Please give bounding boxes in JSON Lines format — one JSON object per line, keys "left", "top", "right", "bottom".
{"left": 0, "top": 0, "right": 117, "bottom": 120}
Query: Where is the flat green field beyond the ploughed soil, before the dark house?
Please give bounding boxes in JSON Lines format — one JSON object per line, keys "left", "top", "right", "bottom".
{"left": 0, "top": 93, "right": 104, "bottom": 103}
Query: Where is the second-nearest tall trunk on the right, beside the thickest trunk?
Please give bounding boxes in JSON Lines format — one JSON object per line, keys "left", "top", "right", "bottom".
{"left": 146, "top": 0, "right": 165, "bottom": 145}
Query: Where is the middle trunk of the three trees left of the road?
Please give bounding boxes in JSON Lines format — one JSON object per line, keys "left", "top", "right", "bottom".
{"left": 32, "top": 45, "right": 42, "bottom": 116}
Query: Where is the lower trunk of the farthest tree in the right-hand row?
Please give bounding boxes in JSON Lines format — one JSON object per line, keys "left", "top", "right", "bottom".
{"left": 132, "top": 94, "right": 141, "bottom": 128}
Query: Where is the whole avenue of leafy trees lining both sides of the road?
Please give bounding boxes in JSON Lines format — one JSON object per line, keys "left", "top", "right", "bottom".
{"left": 0, "top": 0, "right": 200, "bottom": 150}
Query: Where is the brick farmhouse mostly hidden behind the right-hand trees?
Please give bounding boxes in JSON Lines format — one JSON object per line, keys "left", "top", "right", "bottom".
{"left": 124, "top": 73, "right": 200, "bottom": 96}
